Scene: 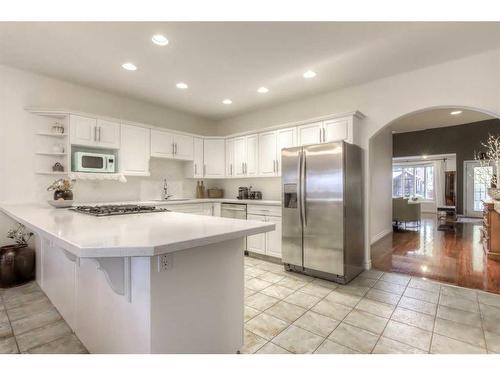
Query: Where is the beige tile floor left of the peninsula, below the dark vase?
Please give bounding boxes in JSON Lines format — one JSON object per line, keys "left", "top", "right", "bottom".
{"left": 0, "top": 282, "right": 87, "bottom": 354}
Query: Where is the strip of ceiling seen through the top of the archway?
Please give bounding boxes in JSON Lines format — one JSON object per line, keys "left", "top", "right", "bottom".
{"left": 390, "top": 107, "right": 494, "bottom": 133}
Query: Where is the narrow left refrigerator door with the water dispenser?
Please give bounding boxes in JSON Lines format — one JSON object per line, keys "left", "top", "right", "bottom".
{"left": 281, "top": 147, "right": 303, "bottom": 267}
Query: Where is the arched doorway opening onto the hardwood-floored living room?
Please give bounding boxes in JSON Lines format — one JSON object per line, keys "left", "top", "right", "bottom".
{"left": 368, "top": 106, "right": 500, "bottom": 293}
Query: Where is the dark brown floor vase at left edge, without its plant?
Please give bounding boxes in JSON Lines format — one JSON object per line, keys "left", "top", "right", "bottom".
{"left": 0, "top": 245, "right": 35, "bottom": 288}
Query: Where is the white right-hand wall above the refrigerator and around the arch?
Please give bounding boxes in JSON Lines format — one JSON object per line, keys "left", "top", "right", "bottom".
{"left": 218, "top": 49, "right": 500, "bottom": 267}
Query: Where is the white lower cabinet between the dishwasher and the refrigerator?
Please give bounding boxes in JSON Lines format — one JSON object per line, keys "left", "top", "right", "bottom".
{"left": 247, "top": 205, "right": 282, "bottom": 258}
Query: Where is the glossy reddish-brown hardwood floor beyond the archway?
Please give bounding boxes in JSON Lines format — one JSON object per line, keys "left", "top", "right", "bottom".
{"left": 371, "top": 214, "right": 500, "bottom": 293}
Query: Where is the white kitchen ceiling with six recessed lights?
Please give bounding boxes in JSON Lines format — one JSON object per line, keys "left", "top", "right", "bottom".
{"left": 0, "top": 22, "right": 500, "bottom": 119}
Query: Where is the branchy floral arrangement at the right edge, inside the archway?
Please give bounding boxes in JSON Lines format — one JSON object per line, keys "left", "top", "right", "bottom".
{"left": 474, "top": 134, "right": 500, "bottom": 200}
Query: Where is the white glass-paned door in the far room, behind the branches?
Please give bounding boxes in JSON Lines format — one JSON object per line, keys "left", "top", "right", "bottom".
{"left": 464, "top": 161, "right": 493, "bottom": 217}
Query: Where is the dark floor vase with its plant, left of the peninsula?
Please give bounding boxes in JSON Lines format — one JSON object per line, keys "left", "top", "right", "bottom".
{"left": 0, "top": 224, "right": 35, "bottom": 287}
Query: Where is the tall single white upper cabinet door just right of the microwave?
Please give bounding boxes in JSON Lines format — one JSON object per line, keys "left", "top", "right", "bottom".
{"left": 118, "top": 125, "right": 150, "bottom": 176}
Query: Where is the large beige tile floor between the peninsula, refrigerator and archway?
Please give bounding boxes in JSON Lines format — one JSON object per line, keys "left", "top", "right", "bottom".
{"left": 241, "top": 257, "right": 500, "bottom": 354}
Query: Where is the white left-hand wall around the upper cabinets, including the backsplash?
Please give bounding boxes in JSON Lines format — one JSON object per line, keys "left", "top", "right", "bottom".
{"left": 0, "top": 65, "right": 215, "bottom": 245}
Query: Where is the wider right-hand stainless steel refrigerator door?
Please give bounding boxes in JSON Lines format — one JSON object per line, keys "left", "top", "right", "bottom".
{"left": 299, "top": 142, "right": 344, "bottom": 276}
